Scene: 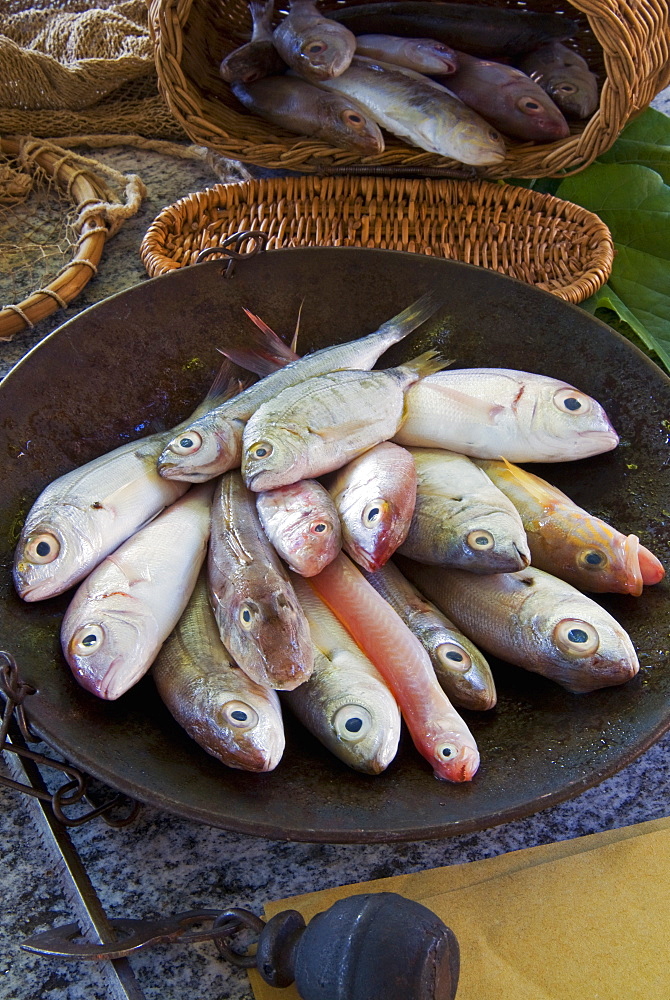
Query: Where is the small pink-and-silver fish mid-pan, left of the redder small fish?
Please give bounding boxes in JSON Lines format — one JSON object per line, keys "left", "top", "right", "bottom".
{"left": 256, "top": 479, "right": 342, "bottom": 576}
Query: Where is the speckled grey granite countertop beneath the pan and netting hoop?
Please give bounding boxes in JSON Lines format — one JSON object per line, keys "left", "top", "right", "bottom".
{"left": 0, "top": 91, "right": 670, "bottom": 1000}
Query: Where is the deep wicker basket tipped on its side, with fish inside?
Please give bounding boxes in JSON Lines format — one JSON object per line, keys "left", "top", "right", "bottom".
{"left": 148, "top": 0, "right": 670, "bottom": 177}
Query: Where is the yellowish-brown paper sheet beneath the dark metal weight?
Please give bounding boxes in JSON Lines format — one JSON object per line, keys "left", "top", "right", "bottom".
{"left": 250, "top": 818, "right": 670, "bottom": 1000}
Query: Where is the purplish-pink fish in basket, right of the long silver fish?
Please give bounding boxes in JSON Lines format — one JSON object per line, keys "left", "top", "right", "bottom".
{"left": 440, "top": 52, "right": 570, "bottom": 142}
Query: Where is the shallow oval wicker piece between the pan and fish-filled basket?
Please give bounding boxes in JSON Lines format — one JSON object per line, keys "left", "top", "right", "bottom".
{"left": 140, "top": 176, "right": 613, "bottom": 303}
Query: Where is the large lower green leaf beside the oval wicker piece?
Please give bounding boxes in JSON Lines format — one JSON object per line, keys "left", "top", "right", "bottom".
{"left": 557, "top": 164, "right": 670, "bottom": 370}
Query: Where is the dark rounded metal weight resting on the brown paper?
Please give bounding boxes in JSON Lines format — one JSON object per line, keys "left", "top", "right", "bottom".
{"left": 256, "top": 892, "right": 460, "bottom": 1000}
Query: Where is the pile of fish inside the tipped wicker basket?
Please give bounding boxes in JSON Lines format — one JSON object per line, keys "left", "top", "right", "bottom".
{"left": 220, "top": 0, "right": 598, "bottom": 166}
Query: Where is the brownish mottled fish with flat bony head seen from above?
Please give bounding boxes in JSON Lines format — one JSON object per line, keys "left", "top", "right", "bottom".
{"left": 208, "top": 471, "right": 314, "bottom": 690}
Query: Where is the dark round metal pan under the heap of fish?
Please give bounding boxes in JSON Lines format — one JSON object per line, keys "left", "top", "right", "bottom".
{"left": 0, "top": 248, "right": 670, "bottom": 842}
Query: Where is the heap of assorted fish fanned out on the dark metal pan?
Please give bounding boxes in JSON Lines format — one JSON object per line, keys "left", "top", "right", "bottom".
{"left": 14, "top": 291, "right": 664, "bottom": 781}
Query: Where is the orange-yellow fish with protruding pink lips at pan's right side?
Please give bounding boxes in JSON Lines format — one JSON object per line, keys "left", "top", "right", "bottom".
{"left": 477, "top": 459, "right": 665, "bottom": 597}
